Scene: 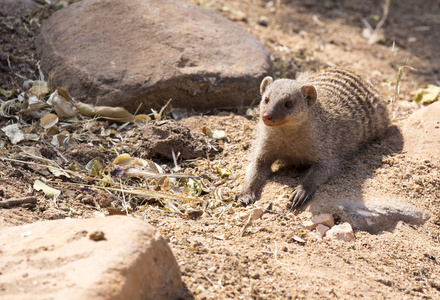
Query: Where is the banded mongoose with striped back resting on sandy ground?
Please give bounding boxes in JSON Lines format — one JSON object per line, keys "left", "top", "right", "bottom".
{"left": 238, "top": 69, "right": 389, "bottom": 209}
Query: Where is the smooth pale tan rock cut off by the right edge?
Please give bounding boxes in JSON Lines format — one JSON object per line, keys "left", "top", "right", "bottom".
{"left": 402, "top": 102, "right": 440, "bottom": 159}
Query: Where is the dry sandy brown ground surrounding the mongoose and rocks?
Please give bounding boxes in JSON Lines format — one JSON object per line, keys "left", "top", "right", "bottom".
{"left": 0, "top": 0, "right": 440, "bottom": 299}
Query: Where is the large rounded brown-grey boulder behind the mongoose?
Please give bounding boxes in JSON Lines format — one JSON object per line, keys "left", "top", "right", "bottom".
{"left": 36, "top": 0, "right": 271, "bottom": 112}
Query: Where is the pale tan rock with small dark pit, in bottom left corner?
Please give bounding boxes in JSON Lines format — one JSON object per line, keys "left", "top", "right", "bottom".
{"left": 0, "top": 216, "right": 187, "bottom": 300}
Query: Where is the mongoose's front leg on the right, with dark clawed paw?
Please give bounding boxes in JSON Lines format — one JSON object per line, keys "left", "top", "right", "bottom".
{"left": 290, "top": 159, "right": 340, "bottom": 209}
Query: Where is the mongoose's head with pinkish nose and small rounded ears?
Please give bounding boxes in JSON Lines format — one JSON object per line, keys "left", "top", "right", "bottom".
{"left": 260, "top": 76, "right": 317, "bottom": 127}
